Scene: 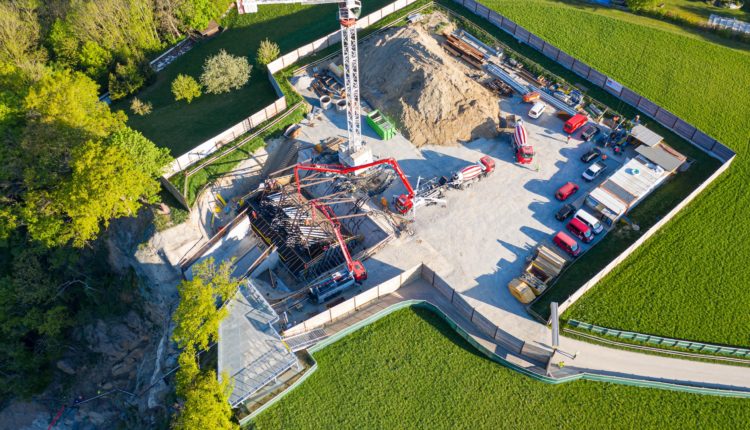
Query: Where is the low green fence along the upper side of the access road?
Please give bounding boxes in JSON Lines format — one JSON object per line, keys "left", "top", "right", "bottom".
{"left": 568, "top": 320, "right": 750, "bottom": 358}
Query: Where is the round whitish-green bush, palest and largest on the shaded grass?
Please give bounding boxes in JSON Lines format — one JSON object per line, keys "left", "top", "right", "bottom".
{"left": 201, "top": 49, "right": 252, "bottom": 94}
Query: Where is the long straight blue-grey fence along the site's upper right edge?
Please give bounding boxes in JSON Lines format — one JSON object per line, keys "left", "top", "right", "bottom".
{"left": 453, "top": 0, "right": 735, "bottom": 162}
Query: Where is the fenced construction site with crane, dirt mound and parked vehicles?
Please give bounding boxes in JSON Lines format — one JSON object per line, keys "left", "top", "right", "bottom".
{"left": 170, "top": 5, "right": 686, "bottom": 418}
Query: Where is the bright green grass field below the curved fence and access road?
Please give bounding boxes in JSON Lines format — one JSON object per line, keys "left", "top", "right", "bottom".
{"left": 253, "top": 308, "right": 750, "bottom": 430}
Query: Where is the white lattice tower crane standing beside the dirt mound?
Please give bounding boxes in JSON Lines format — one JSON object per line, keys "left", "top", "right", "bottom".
{"left": 237, "top": 0, "right": 373, "bottom": 166}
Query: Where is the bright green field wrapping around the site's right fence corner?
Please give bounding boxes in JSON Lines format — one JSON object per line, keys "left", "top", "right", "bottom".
{"left": 476, "top": 0, "right": 750, "bottom": 346}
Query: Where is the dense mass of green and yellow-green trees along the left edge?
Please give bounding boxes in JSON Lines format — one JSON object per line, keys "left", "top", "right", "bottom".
{"left": 0, "top": 0, "right": 235, "bottom": 400}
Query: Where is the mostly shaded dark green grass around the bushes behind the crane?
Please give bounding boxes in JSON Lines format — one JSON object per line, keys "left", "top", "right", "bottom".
{"left": 113, "top": 0, "right": 390, "bottom": 156}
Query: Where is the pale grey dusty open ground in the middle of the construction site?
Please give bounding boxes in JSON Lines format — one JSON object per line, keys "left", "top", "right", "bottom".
{"left": 295, "top": 58, "right": 621, "bottom": 339}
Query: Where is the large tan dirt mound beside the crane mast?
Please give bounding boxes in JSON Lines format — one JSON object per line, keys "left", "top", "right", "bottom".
{"left": 360, "top": 26, "right": 499, "bottom": 146}
